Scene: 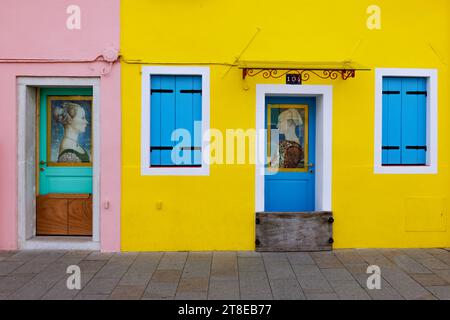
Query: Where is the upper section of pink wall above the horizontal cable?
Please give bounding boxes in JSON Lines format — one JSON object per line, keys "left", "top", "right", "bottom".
{"left": 0, "top": 0, "right": 120, "bottom": 60}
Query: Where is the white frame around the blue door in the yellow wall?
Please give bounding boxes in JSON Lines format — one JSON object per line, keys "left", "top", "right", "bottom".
{"left": 255, "top": 84, "right": 333, "bottom": 212}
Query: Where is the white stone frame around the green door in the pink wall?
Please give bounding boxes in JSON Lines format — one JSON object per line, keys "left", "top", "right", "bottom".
{"left": 17, "top": 77, "right": 100, "bottom": 250}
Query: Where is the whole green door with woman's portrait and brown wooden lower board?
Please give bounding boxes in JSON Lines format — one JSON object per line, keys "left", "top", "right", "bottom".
{"left": 36, "top": 88, "right": 94, "bottom": 236}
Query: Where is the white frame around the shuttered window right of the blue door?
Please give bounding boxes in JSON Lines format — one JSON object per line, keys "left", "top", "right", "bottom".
{"left": 375, "top": 69, "right": 438, "bottom": 174}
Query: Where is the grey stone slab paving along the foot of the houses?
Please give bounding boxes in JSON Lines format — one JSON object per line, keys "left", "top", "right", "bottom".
{"left": 0, "top": 249, "right": 450, "bottom": 300}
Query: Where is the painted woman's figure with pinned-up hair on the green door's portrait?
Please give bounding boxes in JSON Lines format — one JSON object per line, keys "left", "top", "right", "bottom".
{"left": 53, "top": 101, "right": 91, "bottom": 163}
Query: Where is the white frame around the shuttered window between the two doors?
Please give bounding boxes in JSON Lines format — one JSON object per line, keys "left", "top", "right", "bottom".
{"left": 141, "top": 66, "right": 210, "bottom": 176}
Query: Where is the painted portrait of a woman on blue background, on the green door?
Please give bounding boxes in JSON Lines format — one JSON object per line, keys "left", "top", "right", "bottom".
{"left": 51, "top": 101, "right": 91, "bottom": 165}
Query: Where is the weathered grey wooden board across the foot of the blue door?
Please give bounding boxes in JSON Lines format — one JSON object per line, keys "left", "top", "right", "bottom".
{"left": 256, "top": 212, "right": 334, "bottom": 252}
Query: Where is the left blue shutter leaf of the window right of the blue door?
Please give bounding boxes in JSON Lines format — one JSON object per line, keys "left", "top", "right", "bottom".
{"left": 382, "top": 78, "right": 402, "bottom": 165}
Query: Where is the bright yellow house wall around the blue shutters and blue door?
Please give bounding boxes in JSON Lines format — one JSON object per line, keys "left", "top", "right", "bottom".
{"left": 121, "top": 0, "right": 450, "bottom": 251}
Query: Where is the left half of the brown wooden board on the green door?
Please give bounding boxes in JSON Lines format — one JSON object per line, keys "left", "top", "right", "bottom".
{"left": 36, "top": 195, "right": 68, "bottom": 236}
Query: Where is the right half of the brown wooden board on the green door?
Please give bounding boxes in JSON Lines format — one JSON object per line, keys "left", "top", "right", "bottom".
{"left": 68, "top": 196, "right": 92, "bottom": 236}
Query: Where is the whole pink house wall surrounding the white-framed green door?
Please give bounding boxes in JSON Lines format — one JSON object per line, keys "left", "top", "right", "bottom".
{"left": 0, "top": 0, "right": 121, "bottom": 251}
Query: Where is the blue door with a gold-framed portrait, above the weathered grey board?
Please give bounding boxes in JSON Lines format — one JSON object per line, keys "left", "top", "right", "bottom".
{"left": 265, "top": 97, "right": 316, "bottom": 212}
